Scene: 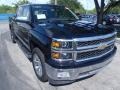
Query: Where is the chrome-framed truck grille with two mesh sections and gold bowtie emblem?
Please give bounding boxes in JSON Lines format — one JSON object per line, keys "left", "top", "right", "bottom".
{"left": 75, "top": 33, "right": 116, "bottom": 61}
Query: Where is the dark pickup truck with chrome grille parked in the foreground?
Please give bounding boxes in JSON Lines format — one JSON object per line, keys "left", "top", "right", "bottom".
{"left": 9, "top": 4, "right": 116, "bottom": 85}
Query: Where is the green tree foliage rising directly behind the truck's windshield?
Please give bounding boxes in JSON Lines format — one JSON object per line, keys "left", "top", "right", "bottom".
{"left": 50, "top": 0, "right": 85, "bottom": 12}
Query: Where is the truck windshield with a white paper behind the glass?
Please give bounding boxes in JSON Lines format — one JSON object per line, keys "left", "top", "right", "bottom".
{"left": 33, "top": 6, "right": 78, "bottom": 21}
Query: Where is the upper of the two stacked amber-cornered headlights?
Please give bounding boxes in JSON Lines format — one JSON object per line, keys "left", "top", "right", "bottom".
{"left": 51, "top": 41, "right": 72, "bottom": 49}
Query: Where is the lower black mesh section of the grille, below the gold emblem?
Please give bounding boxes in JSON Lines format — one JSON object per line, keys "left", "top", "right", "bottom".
{"left": 76, "top": 45, "right": 114, "bottom": 60}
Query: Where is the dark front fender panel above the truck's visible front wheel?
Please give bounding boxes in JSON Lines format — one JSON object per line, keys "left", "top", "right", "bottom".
{"left": 30, "top": 30, "right": 51, "bottom": 58}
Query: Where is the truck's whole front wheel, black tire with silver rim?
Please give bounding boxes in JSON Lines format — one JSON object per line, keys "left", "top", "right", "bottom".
{"left": 32, "top": 48, "right": 48, "bottom": 82}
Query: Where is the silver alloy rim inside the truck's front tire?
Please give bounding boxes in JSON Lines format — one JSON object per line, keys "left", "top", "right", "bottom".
{"left": 33, "top": 54, "right": 43, "bottom": 77}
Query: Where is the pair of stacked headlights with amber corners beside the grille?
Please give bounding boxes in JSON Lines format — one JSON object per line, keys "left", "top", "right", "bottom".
{"left": 51, "top": 39, "right": 73, "bottom": 61}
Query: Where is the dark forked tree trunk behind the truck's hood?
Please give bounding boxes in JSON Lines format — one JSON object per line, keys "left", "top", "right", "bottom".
{"left": 94, "top": 0, "right": 120, "bottom": 24}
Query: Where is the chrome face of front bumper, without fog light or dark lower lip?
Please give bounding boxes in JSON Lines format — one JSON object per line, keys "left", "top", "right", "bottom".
{"left": 46, "top": 58, "right": 112, "bottom": 80}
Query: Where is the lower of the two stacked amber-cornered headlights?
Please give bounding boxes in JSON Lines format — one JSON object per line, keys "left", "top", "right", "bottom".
{"left": 51, "top": 52, "right": 73, "bottom": 60}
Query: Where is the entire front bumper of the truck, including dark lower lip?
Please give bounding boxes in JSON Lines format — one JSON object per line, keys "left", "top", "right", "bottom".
{"left": 46, "top": 48, "right": 116, "bottom": 85}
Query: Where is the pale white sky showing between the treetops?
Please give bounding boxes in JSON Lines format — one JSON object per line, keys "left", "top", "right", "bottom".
{"left": 0, "top": 0, "right": 95, "bottom": 10}
